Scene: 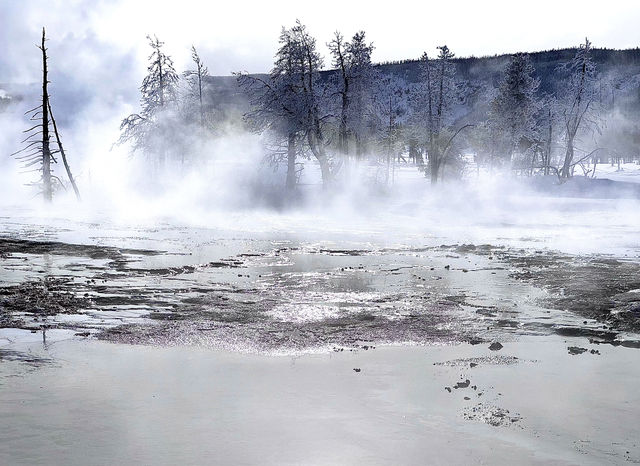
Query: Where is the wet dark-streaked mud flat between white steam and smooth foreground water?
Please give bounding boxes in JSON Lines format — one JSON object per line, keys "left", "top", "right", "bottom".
{"left": 0, "top": 238, "right": 640, "bottom": 353}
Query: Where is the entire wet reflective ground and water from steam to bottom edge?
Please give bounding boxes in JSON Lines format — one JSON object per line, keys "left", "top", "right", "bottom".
{"left": 0, "top": 202, "right": 640, "bottom": 464}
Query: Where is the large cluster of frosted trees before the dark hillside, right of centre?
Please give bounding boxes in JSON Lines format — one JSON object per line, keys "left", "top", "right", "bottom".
{"left": 237, "top": 22, "right": 605, "bottom": 188}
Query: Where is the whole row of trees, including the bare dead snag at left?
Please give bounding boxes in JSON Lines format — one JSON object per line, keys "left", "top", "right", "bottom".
{"left": 17, "top": 25, "right": 632, "bottom": 199}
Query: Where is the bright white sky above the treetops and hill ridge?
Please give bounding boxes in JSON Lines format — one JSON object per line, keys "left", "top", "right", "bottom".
{"left": 0, "top": 0, "right": 640, "bottom": 81}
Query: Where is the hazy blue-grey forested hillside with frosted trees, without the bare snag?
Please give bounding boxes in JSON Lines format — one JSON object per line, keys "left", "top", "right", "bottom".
{"left": 5, "top": 27, "right": 640, "bottom": 198}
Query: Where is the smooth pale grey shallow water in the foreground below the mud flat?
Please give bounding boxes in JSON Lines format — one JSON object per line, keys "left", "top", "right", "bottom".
{"left": 0, "top": 337, "right": 640, "bottom": 464}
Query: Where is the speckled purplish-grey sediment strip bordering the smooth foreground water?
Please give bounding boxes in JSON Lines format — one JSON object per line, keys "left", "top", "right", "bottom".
{"left": 98, "top": 308, "right": 480, "bottom": 352}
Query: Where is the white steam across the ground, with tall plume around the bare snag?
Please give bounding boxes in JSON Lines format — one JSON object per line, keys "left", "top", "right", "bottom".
{"left": 0, "top": 2, "right": 640, "bottom": 262}
